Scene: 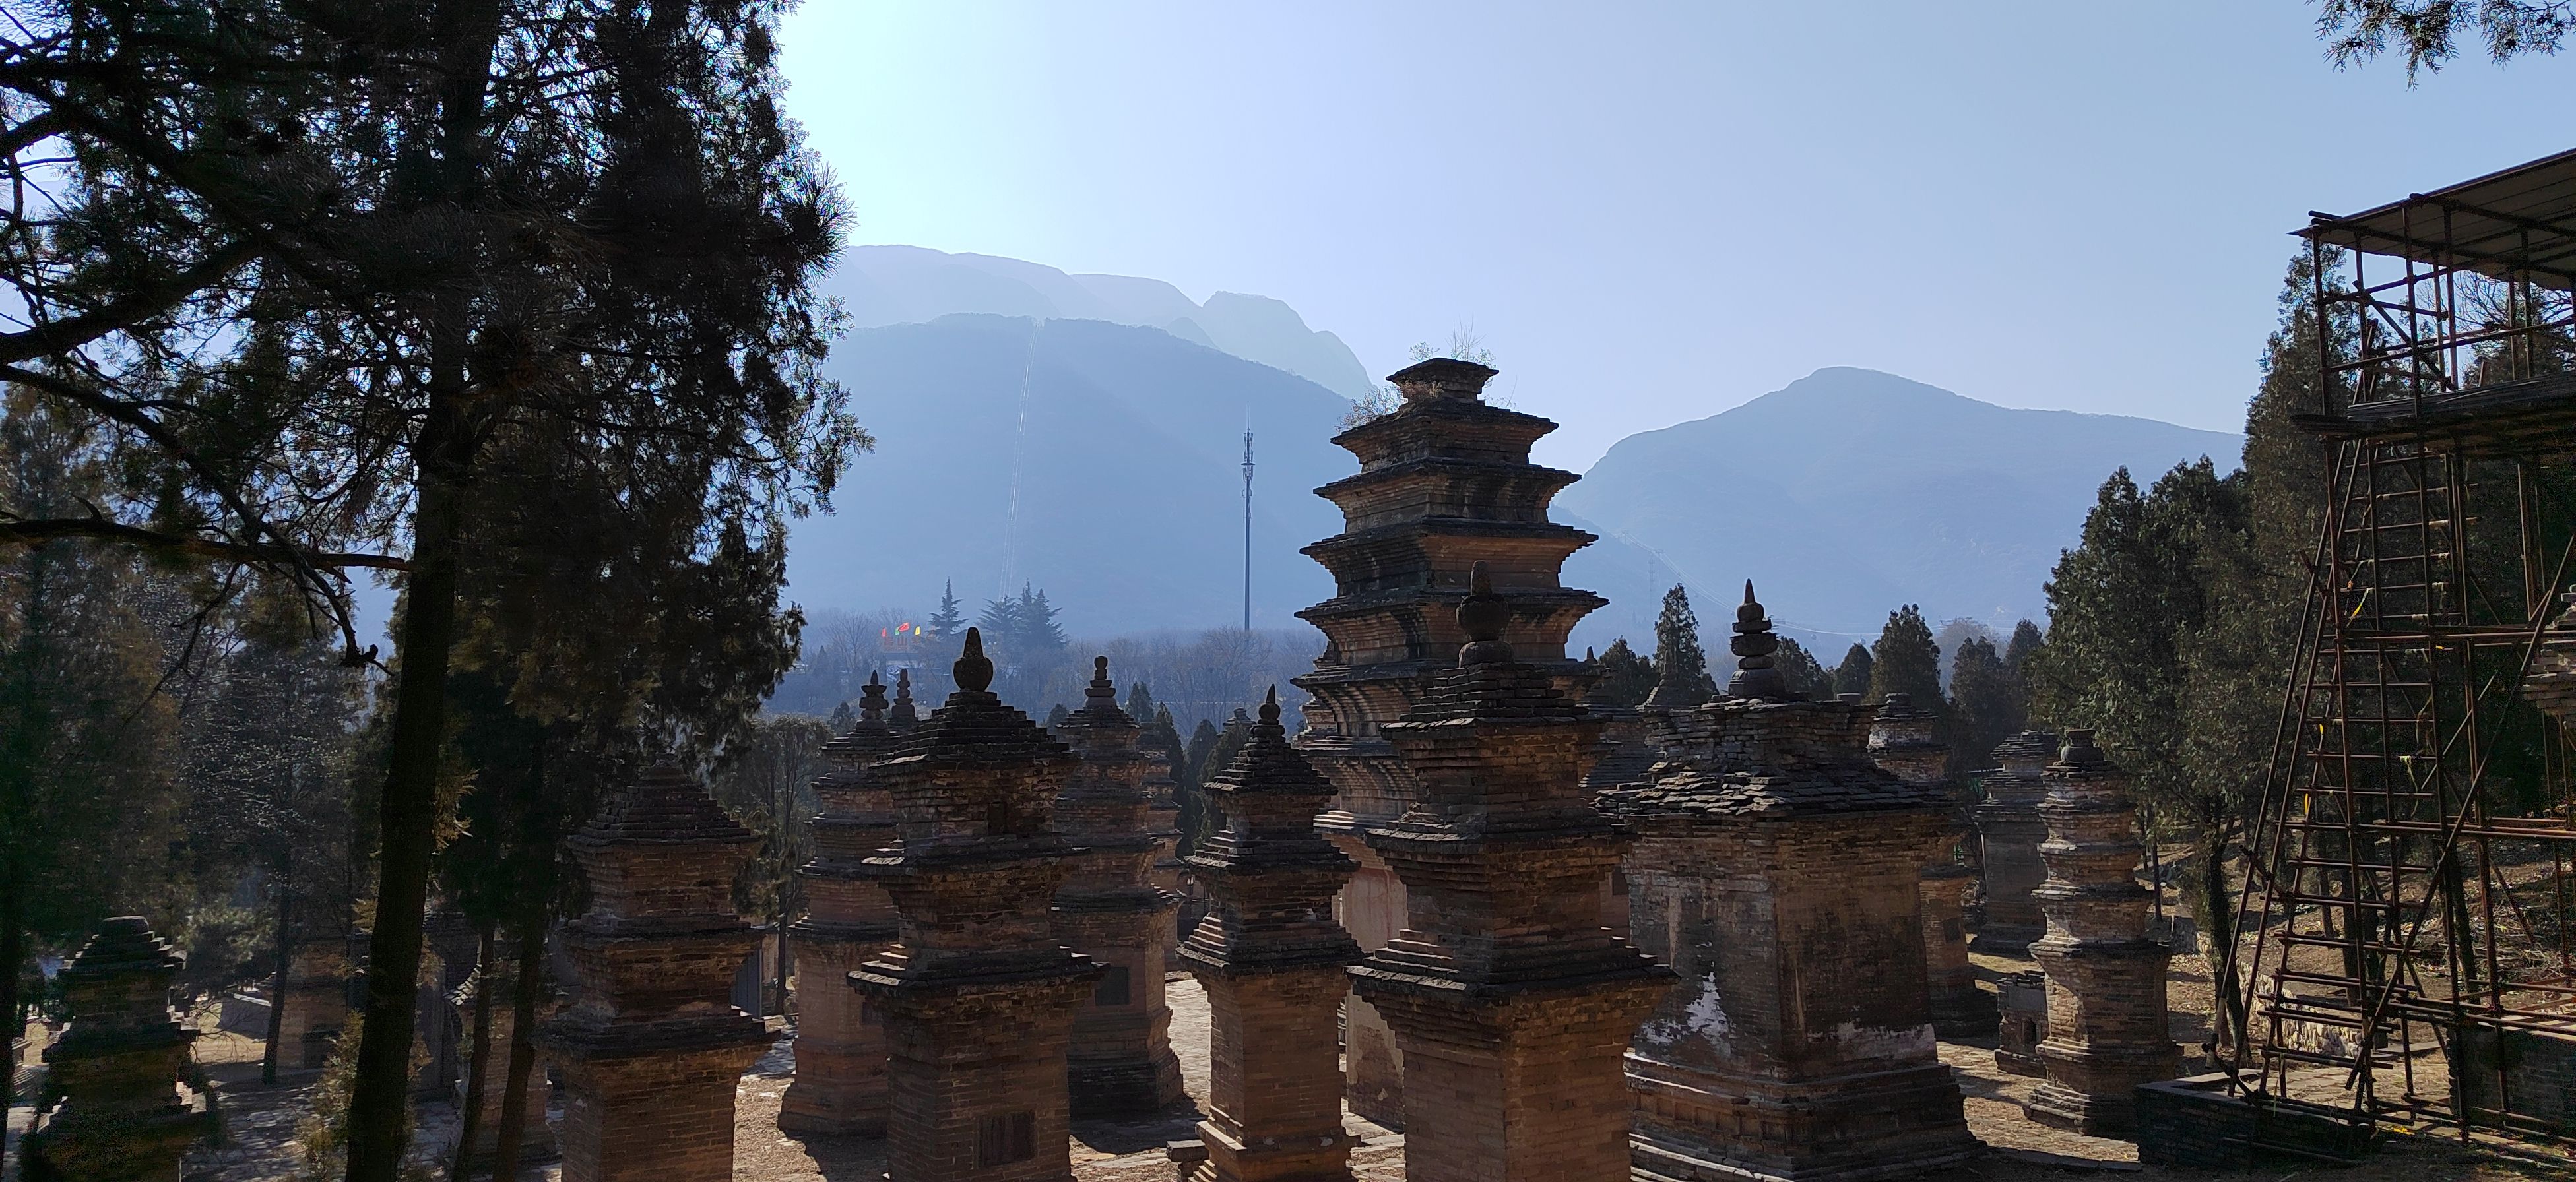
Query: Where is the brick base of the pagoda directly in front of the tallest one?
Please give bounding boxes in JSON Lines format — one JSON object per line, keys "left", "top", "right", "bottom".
{"left": 1360, "top": 976, "right": 1672, "bottom": 1182}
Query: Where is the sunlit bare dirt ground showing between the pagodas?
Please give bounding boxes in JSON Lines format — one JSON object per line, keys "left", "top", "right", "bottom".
{"left": 171, "top": 953, "right": 2576, "bottom": 1182}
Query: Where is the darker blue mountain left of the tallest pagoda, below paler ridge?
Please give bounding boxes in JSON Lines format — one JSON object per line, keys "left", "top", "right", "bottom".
{"left": 789, "top": 313, "right": 1675, "bottom": 652}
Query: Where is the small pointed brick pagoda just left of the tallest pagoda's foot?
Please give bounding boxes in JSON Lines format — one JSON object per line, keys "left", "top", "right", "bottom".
{"left": 1180, "top": 690, "right": 1360, "bottom": 1182}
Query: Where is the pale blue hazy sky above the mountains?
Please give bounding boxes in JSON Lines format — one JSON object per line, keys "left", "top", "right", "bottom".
{"left": 783, "top": 0, "right": 2576, "bottom": 469}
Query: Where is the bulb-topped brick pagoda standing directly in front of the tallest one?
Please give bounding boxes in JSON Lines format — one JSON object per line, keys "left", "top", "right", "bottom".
{"left": 1350, "top": 561, "right": 1672, "bottom": 1182}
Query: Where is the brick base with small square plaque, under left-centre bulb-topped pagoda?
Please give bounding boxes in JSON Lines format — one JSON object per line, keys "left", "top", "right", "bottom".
{"left": 863, "top": 971, "right": 1092, "bottom": 1182}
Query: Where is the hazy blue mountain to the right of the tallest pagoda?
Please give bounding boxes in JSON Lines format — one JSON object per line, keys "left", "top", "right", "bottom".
{"left": 1564, "top": 368, "right": 2243, "bottom": 644}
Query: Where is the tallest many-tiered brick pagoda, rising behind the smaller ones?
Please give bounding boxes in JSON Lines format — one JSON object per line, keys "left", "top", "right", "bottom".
{"left": 1296, "top": 358, "right": 1607, "bottom": 1128}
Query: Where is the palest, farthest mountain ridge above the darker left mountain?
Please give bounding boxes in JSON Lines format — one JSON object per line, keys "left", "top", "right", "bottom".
{"left": 824, "top": 247, "right": 1373, "bottom": 399}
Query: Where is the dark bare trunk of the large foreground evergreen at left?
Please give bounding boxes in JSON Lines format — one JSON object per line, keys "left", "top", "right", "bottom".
{"left": 348, "top": 399, "right": 471, "bottom": 1182}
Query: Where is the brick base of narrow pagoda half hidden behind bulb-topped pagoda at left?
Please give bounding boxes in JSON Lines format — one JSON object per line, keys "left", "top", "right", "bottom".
{"left": 778, "top": 925, "right": 894, "bottom": 1136}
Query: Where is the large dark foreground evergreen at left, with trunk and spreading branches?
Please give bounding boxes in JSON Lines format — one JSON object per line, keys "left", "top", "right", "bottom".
{"left": 0, "top": 0, "right": 863, "bottom": 1182}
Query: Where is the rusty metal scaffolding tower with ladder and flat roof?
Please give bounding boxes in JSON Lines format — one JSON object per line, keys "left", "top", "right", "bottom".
{"left": 2220, "top": 152, "right": 2576, "bottom": 1143}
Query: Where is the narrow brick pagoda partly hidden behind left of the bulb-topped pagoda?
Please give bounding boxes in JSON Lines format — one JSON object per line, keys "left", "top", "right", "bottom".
{"left": 778, "top": 672, "right": 909, "bottom": 1136}
